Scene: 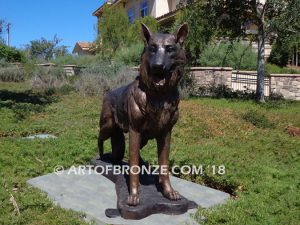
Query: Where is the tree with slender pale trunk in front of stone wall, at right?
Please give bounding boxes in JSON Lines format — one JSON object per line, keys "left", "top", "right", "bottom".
{"left": 207, "top": 0, "right": 300, "bottom": 102}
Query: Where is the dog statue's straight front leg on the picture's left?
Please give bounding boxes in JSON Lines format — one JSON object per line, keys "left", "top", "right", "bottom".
{"left": 127, "top": 129, "right": 141, "bottom": 206}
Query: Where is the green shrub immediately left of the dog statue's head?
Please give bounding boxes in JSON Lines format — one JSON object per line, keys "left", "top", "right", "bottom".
{"left": 115, "top": 43, "right": 144, "bottom": 66}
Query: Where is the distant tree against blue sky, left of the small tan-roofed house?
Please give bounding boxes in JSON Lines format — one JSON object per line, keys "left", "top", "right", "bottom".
{"left": 26, "top": 35, "right": 67, "bottom": 60}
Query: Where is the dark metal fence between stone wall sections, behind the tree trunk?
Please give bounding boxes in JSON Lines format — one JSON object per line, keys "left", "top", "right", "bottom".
{"left": 231, "top": 71, "right": 270, "bottom": 96}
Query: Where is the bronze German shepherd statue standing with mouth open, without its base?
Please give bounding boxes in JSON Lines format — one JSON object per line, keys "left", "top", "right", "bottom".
{"left": 98, "top": 24, "right": 188, "bottom": 206}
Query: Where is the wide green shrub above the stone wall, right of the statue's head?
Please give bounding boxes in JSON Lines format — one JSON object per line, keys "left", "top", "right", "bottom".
{"left": 198, "top": 42, "right": 257, "bottom": 70}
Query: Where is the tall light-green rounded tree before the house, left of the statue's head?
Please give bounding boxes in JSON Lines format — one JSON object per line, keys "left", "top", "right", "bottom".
{"left": 97, "top": 5, "right": 129, "bottom": 54}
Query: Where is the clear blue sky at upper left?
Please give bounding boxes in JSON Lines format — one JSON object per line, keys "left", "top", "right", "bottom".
{"left": 0, "top": 0, "right": 104, "bottom": 52}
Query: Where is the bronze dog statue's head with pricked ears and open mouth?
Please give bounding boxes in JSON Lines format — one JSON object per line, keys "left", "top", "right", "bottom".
{"left": 140, "top": 23, "right": 188, "bottom": 91}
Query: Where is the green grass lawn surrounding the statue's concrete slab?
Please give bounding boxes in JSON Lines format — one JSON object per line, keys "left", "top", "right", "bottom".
{"left": 0, "top": 83, "right": 300, "bottom": 225}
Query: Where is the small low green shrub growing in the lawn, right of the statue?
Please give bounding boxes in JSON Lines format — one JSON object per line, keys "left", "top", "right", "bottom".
{"left": 242, "top": 109, "right": 274, "bottom": 128}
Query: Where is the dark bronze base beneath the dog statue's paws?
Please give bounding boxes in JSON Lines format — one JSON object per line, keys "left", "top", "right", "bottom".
{"left": 91, "top": 154, "right": 198, "bottom": 220}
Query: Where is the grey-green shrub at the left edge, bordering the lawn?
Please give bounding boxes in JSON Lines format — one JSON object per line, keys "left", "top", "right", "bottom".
{"left": 0, "top": 66, "right": 25, "bottom": 82}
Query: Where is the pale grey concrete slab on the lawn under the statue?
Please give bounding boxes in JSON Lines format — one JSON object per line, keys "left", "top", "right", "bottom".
{"left": 28, "top": 167, "right": 230, "bottom": 225}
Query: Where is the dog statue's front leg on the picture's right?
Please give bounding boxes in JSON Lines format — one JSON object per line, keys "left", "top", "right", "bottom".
{"left": 156, "top": 131, "right": 181, "bottom": 201}
